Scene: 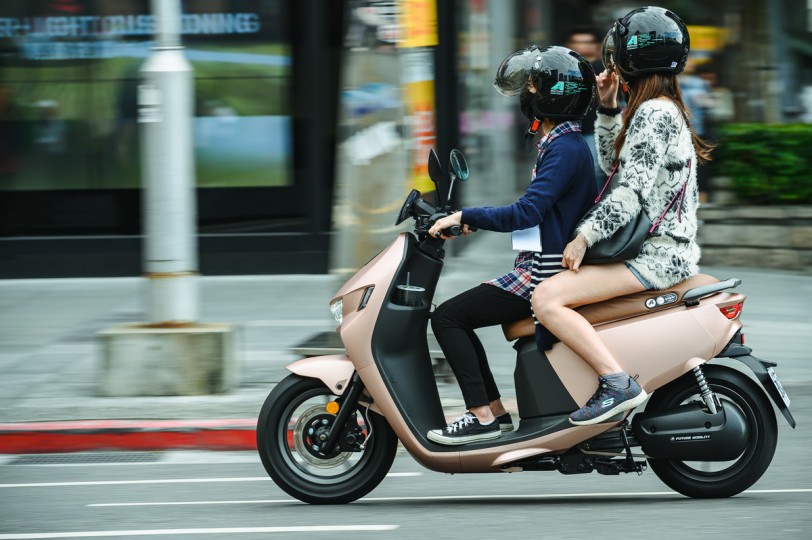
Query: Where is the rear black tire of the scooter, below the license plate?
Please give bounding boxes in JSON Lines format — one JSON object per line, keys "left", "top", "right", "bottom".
{"left": 646, "top": 366, "right": 778, "bottom": 499}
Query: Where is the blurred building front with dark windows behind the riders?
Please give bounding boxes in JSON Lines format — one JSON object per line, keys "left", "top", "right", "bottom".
{"left": 0, "top": 0, "right": 812, "bottom": 277}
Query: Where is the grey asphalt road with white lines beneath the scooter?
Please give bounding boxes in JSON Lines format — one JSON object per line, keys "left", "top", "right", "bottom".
{"left": 0, "top": 384, "right": 812, "bottom": 540}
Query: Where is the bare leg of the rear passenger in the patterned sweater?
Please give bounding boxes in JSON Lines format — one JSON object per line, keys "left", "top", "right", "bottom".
{"left": 531, "top": 263, "right": 645, "bottom": 375}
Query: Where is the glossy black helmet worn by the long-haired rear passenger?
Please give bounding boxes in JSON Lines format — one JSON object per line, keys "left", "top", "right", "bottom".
{"left": 601, "top": 6, "right": 691, "bottom": 77}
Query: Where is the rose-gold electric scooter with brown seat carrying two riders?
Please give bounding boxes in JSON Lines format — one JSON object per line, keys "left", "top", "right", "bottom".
{"left": 257, "top": 150, "right": 795, "bottom": 504}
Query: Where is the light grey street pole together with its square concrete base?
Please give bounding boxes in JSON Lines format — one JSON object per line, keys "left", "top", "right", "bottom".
{"left": 97, "top": 0, "right": 238, "bottom": 396}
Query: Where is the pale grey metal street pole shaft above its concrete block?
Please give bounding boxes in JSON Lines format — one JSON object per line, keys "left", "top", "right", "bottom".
{"left": 138, "top": 0, "right": 199, "bottom": 326}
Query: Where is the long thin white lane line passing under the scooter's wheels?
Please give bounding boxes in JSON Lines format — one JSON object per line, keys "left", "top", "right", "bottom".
{"left": 85, "top": 488, "right": 812, "bottom": 508}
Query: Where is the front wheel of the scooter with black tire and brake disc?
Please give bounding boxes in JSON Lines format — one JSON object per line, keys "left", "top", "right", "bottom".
{"left": 257, "top": 375, "right": 398, "bottom": 504}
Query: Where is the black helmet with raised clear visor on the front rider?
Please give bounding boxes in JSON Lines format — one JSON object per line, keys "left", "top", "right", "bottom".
{"left": 493, "top": 45, "right": 595, "bottom": 120}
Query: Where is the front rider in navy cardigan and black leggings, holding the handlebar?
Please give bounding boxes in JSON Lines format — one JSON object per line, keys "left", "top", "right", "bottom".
{"left": 427, "top": 46, "right": 597, "bottom": 444}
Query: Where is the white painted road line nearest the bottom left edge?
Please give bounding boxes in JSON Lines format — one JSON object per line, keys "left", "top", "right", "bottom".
{"left": 0, "top": 525, "right": 399, "bottom": 540}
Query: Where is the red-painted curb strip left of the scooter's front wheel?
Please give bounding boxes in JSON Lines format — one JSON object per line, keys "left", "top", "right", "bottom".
{"left": 0, "top": 420, "right": 257, "bottom": 454}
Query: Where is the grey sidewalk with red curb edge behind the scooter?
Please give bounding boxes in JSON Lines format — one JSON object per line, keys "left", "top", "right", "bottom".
{"left": 0, "top": 233, "right": 812, "bottom": 453}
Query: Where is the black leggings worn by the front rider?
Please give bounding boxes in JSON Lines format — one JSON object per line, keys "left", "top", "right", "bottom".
{"left": 431, "top": 283, "right": 532, "bottom": 409}
